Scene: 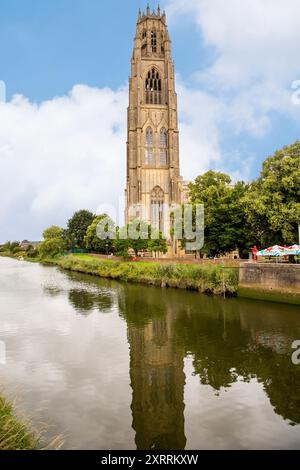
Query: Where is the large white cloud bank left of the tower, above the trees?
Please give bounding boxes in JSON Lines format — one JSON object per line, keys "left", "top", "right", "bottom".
{"left": 0, "top": 85, "right": 127, "bottom": 240}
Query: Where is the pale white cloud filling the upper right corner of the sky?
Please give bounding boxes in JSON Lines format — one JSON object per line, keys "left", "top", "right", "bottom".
{"left": 168, "top": 0, "right": 300, "bottom": 88}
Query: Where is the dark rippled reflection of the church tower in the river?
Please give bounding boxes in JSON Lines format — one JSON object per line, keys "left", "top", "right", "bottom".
{"left": 128, "top": 312, "right": 186, "bottom": 450}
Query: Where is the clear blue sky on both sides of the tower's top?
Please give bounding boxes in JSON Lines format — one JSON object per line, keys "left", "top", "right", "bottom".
{"left": 0, "top": 0, "right": 204, "bottom": 102}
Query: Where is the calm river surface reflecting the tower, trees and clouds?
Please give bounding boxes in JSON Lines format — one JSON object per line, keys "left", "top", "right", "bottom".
{"left": 0, "top": 258, "right": 300, "bottom": 449}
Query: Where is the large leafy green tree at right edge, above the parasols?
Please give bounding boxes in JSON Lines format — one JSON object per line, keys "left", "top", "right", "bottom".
{"left": 242, "top": 141, "right": 300, "bottom": 247}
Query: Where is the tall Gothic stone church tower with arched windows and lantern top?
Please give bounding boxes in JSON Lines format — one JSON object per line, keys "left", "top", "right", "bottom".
{"left": 126, "top": 5, "right": 185, "bottom": 234}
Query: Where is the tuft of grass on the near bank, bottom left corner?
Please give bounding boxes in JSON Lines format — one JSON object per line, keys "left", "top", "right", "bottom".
{"left": 0, "top": 395, "right": 39, "bottom": 450}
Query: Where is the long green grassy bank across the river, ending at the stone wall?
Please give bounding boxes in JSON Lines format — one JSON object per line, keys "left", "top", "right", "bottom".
{"left": 48, "top": 255, "right": 238, "bottom": 295}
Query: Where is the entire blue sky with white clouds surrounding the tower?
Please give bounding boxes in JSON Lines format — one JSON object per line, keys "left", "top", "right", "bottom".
{"left": 0, "top": 0, "right": 300, "bottom": 242}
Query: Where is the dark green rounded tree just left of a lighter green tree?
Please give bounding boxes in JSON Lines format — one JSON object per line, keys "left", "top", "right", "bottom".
{"left": 66, "top": 209, "right": 96, "bottom": 249}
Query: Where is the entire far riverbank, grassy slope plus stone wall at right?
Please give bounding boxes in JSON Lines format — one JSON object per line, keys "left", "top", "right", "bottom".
{"left": 0, "top": 253, "right": 300, "bottom": 305}
